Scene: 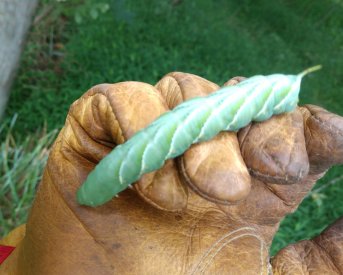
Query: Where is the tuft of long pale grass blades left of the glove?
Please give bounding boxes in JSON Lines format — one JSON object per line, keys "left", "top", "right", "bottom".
{"left": 0, "top": 116, "right": 56, "bottom": 236}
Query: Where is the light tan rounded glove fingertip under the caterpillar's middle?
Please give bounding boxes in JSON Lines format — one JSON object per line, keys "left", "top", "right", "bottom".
{"left": 179, "top": 132, "right": 251, "bottom": 204}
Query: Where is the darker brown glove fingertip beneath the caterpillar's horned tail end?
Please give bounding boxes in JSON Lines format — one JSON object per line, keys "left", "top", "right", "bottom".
{"left": 238, "top": 109, "right": 309, "bottom": 184}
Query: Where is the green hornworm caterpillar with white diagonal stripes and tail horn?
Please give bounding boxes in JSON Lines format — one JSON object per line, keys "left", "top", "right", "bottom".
{"left": 77, "top": 66, "right": 320, "bottom": 206}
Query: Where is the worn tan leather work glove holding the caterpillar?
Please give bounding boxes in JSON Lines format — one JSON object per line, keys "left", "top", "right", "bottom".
{"left": 0, "top": 73, "right": 343, "bottom": 275}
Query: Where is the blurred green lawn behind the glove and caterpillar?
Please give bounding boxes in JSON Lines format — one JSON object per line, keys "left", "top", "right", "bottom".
{"left": 0, "top": 0, "right": 343, "bottom": 254}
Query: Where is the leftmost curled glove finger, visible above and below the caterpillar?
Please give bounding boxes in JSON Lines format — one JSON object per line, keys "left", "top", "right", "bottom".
{"left": 69, "top": 82, "right": 187, "bottom": 211}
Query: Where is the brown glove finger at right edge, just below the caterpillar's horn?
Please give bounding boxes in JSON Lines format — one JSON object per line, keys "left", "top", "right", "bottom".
{"left": 300, "top": 105, "right": 343, "bottom": 174}
